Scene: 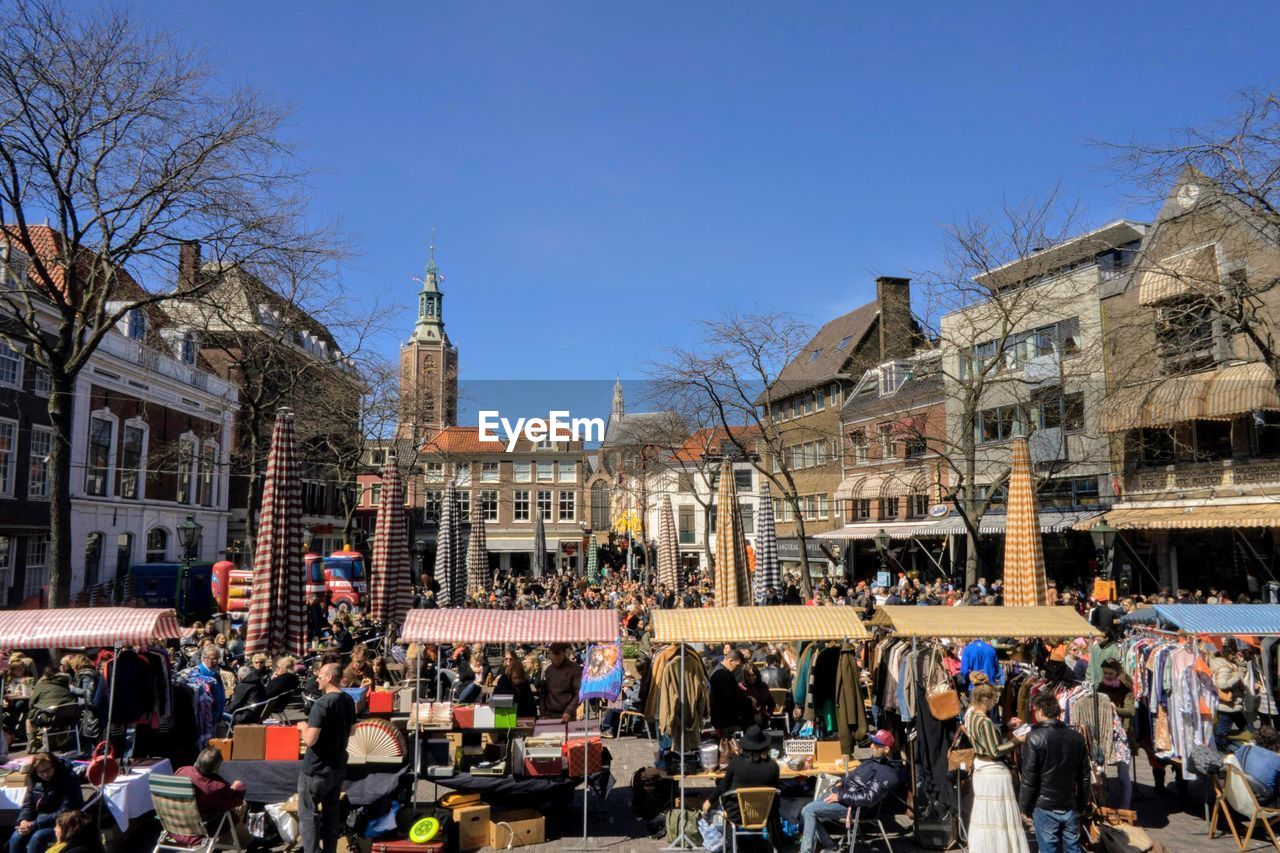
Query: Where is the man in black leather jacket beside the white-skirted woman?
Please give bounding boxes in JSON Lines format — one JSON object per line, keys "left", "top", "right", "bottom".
{"left": 1018, "top": 693, "right": 1089, "bottom": 853}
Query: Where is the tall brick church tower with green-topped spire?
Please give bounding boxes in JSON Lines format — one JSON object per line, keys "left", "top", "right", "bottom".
{"left": 396, "top": 243, "right": 458, "bottom": 441}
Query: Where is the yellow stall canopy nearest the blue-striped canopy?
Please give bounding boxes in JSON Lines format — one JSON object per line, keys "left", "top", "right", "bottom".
{"left": 872, "top": 605, "right": 1102, "bottom": 639}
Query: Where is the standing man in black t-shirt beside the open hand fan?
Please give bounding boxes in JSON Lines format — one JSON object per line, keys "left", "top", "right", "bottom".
{"left": 298, "top": 663, "right": 356, "bottom": 853}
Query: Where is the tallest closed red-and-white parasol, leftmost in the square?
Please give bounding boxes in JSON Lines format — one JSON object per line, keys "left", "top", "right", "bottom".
{"left": 244, "top": 409, "right": 306, "bottom": 654}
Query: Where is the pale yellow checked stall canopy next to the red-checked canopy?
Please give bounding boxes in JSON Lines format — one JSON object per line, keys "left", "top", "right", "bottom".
{"left": 653, "top": 605, "right": 869, "bottom": 643}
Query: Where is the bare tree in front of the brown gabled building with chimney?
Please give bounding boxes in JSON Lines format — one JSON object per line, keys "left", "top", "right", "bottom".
{"left": 650, "top": 313, "right": 838, "bottom": 597}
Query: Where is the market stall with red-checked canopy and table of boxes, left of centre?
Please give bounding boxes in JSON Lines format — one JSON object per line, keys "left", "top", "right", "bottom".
{"left": 401, "top": 608, "right": 621, "bottom": 845}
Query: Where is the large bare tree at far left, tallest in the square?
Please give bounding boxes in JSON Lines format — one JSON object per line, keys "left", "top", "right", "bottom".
{"left": 0, "top": 0, "right": 322, "bottom": 607}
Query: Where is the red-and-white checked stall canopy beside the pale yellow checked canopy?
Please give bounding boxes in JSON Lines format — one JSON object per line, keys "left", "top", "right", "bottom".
{"left": 401, "top": 608, "right": 618, "bottom": 644}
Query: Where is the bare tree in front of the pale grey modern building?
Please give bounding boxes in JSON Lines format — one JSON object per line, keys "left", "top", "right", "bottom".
{"left": 910, "top": 195, "right": 1128, "bottom": 585}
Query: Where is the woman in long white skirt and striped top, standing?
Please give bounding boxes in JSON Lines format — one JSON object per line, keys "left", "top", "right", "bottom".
{"left": 964, "top": 684, "right": 1029, "bottom": 853}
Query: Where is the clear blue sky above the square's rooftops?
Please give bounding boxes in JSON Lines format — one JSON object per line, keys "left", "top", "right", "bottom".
{"left": 132, "top": 0, "right": 1280, "bottom": 420}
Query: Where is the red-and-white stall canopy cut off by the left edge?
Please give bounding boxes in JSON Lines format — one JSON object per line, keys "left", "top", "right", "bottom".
{"left": 0, "top": 607, "right": 182, "bottom": 649}
